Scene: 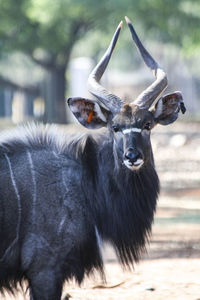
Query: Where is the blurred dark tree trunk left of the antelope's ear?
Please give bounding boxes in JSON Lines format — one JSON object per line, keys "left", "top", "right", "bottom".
{"left": 44, "top": 66, "right": 67, "bottom": 123}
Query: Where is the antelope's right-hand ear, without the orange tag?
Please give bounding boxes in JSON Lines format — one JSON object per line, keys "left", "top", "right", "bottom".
{"left": 151, "top": 92, "right": 186, "bottom": 125}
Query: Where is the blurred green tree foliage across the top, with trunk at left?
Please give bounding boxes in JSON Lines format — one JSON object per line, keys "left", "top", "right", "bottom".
{"left": 0, "top": 0, "right": 200, "bottom": 123}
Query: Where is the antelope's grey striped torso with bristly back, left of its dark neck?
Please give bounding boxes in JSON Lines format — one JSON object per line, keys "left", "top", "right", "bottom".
{"left": 0, "top": 125, "right": 94, "bottom": 288}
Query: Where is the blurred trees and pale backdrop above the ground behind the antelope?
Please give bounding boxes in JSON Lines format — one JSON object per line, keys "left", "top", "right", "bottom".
{"left": 0, "top": 0, "right": 200, "bottom": 123}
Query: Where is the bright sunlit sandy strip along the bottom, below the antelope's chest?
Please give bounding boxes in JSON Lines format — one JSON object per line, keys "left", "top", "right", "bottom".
{"left": 63, "top": 259, "right": 200, "bottom": 300}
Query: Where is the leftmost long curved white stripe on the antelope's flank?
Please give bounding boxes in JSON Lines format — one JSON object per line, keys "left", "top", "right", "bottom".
{"left": 0, "top": 154, "right": 22, "bottom": 261}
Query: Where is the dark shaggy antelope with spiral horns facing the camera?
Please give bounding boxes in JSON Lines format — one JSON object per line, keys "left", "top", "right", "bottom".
{"left": 0, "top": 19, "right": 185, "bottom": 300}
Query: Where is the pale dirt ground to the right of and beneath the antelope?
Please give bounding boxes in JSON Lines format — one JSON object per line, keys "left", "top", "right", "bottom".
{"left": 0, "top": 123, "right": 200, "bottom": 300}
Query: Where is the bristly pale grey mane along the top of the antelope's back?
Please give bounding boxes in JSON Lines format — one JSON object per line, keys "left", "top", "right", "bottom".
{"left": 0, "top": 123, "right": 102, "bottom": 159}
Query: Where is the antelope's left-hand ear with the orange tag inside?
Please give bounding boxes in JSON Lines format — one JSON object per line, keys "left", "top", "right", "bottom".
{"left": 67, "top": 97, "right": 110, "bottom": 129}
